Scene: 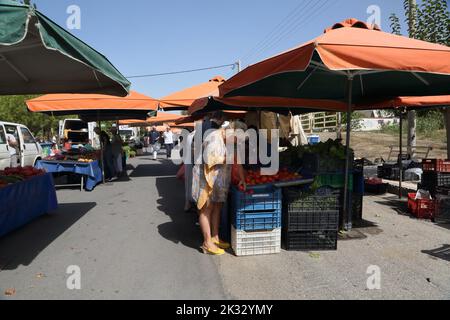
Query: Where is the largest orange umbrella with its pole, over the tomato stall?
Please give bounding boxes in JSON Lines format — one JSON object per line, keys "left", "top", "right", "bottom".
{"left": 214, "top": 19, "right": 450, "bottom": 229}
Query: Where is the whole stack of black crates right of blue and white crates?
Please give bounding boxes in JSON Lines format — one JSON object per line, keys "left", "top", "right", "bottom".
{"left": 282, "top": 187, "right": 340, "bottom": 250}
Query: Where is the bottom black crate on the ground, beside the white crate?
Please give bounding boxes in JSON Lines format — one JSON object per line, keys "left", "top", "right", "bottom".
{"left": 283, "top": 230, "right": 338, "bottom": 251}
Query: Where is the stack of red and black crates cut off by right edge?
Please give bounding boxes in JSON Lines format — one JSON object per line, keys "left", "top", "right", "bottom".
{"left": 421, "top": 159, "right": 450, "bottom": 196}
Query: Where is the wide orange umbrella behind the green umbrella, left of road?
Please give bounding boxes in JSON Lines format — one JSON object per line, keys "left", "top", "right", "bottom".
{"left": 26, "top": 91, "right": 158, "bottom": 121}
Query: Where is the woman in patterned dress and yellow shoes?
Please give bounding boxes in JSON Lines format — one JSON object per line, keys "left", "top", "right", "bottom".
{"left": 192, "top": 117, "right": 247, "bottom": 255}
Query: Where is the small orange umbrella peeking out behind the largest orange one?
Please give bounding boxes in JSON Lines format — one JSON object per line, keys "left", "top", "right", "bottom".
{"left": 160, "top": 76, "right": 225, "bottom": 110}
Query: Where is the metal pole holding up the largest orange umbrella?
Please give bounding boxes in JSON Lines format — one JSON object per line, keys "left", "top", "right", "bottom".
{"left": 343, "top": 74, "right": 353, "bottom": 231}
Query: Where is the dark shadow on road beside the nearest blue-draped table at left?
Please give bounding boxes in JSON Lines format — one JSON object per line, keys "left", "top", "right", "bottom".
{"left": 0, "top": 202, "right": 97, "bottom": 271}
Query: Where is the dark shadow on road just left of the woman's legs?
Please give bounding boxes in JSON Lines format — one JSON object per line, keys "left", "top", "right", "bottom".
{"left": 156, "top": 175, "right": 202, "bottom": 250}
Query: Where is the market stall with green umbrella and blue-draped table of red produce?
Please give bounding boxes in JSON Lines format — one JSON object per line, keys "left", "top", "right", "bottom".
{"left": 0, "top": 0, "right": 130, "bottom": 236}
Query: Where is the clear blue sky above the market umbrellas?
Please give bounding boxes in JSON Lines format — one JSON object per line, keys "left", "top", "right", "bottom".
{"left": 32, "top": 0, "right": 406, "bottom": 98}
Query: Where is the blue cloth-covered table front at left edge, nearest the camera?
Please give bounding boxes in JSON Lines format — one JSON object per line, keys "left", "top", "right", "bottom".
{"left": 0, "top": 173, "right": 58, "bottom": 237}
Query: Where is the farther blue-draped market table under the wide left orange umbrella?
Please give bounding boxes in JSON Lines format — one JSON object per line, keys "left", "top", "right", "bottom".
{"left": 36, "top": 160, "right": 103, "bottom": 191}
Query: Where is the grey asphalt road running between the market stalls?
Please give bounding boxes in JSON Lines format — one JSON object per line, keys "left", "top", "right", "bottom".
{"left": 0, "top": 156, "right": 450, "bottom": 300}
